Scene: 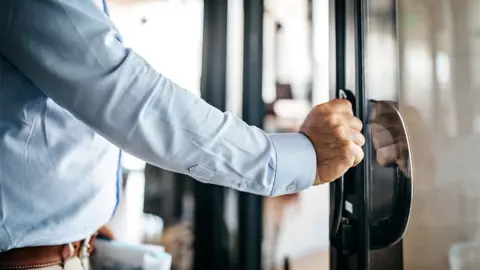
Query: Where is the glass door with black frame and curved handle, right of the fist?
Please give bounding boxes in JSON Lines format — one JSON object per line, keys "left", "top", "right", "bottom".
{"left": 330, "top": 0, "right": 480, "bottom": 270}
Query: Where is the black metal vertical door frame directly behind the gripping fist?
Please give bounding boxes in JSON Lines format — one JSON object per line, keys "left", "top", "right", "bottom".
{"left": 329, "top": 0, "right": 371, "bottom": 270}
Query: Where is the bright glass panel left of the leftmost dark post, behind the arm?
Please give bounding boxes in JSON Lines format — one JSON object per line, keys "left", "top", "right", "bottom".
{"left": 108, "top": 0, "right": 203, "bottom": 269}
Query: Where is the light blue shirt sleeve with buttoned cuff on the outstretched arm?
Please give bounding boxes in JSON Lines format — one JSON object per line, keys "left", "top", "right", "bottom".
{"left": 0, "top": 0, "right": 316, "bottom": 196}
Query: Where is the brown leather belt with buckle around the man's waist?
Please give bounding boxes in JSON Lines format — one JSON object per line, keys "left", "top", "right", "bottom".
{"left": 0, "top": 237, "right": 95, "bottom": 270}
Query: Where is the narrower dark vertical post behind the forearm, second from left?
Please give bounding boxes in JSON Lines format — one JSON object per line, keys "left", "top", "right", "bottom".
{"left": 238, "top": 0, "right": 265, "bottom": 270}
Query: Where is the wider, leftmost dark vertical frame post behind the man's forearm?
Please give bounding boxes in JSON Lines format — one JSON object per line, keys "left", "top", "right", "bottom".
{"left": 194, "top": 0, "right": 230, "bottom": 270}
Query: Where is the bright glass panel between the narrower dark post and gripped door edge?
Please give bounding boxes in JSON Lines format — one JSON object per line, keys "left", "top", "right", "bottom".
{"left": 263, "top": 0, "right": 329, "bottom": 270}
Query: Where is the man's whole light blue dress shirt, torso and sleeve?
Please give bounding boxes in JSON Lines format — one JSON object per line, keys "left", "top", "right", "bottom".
{"left": 0, "top": 0, "right": 316, "bottom": 251}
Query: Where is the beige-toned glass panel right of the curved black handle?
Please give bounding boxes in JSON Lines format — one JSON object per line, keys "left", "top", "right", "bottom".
{"left": 398, "top": 0, "right": 480, "bottom": 270}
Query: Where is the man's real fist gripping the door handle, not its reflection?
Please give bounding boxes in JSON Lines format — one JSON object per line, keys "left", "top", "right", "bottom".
{"left": 300, "top": 99, "right": 365, "bottom": 185}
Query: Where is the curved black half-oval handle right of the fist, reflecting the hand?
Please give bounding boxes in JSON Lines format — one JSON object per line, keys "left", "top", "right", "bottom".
{"left": 367, "top": 100, "right": 413, "bottom": 250}
